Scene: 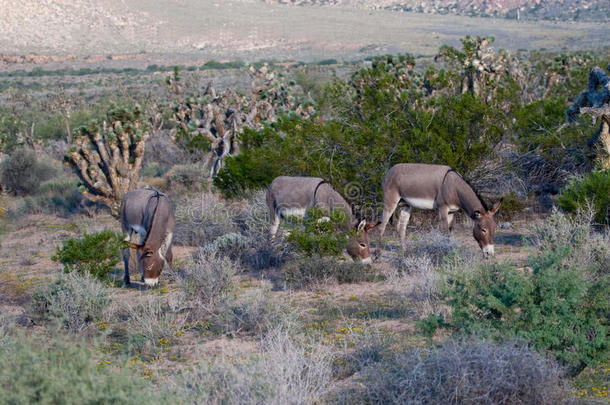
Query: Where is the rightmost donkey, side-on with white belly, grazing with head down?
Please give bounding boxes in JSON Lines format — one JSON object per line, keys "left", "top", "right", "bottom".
{"left": 379, "top": 163, "right": 501, "bottom": 256}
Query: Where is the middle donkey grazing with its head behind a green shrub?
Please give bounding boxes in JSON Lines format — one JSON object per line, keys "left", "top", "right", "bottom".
{"left": 266, "top": 176, "right": 378, "bottom": 264}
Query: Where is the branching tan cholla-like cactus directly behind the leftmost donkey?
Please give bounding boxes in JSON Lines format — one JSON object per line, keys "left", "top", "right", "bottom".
{"left": 64, "top": 106, "right": 149, "bottom": 216}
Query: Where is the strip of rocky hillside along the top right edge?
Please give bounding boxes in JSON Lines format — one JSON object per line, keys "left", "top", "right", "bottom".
{"left": 262, "top": 0, "right": 610, "bottom": 22}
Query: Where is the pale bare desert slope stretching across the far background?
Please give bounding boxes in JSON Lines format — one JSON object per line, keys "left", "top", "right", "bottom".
{"left": 0, "top": 0, "right": 610, "bottom": 63}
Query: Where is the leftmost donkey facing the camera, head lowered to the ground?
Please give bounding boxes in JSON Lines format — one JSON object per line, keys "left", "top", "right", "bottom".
{"left": 121, "top": 189, "right": 175, "bottom": 287}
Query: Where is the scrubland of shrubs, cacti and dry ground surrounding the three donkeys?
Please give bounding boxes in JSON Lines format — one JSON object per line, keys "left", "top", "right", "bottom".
{"left": 0, "top": 33, "right": 610, "bottom": 404}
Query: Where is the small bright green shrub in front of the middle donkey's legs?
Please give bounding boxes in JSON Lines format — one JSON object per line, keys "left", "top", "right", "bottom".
{"left": 288, "top": 208, "right": 349, "bottom": 256}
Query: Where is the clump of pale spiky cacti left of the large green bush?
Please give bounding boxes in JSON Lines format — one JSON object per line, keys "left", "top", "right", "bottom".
{"left": 172, "top": 65, "right": 313, "bottom": 176}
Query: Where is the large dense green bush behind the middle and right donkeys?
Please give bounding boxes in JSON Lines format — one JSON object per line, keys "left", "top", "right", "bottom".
{"left": 214, "top": 72, "right": 503, "bottom": 205}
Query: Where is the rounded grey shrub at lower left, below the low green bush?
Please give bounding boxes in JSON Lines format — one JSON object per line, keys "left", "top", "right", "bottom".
{"left": 32, "top": 273, "right": 110, "bottom": 332}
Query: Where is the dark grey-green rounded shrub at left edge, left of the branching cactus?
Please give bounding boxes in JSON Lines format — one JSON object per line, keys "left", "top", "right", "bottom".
{"left": 0, "top": 148, "right": 56, "bottom": 195}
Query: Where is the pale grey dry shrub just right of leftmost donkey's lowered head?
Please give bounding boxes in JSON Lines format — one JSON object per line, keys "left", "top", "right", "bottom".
{"left": 178, "top": 250, "right": 238, "bottom": 307}
